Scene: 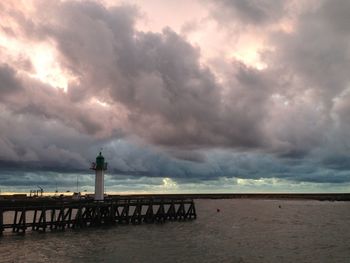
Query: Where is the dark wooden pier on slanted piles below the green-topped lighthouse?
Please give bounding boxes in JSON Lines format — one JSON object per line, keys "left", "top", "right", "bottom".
{"left": 0, "top": 197, "right": 197, "bottom": 235}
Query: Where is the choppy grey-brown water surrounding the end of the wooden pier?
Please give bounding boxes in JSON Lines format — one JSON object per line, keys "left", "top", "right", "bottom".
{"left": 0, "top": 200, "right": 350, "bottom": 263}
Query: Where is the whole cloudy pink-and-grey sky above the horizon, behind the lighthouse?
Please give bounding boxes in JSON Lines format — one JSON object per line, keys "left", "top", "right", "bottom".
{"left": 0, "top": 0, "right": 350, "bottom": 193}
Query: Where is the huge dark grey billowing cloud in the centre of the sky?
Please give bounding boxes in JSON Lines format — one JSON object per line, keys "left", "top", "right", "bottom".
{"left": 8, "top": 2, "right": 270, "bottom": 151}
